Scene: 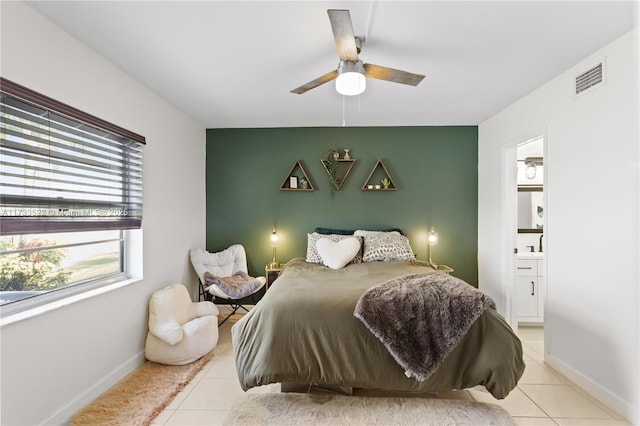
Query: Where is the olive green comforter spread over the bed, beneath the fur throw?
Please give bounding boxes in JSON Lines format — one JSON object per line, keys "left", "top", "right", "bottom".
{"left": 231, "top": 261, "right": 524, "bottom": 399}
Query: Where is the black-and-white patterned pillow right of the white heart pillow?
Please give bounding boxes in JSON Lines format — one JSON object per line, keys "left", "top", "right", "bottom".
{"left": 354, "top": 231, "right": 416, "bottom": 262}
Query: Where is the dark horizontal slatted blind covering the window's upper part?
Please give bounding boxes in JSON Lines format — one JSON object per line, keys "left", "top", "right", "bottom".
{"left": 0, "top": 79, "right": 145, "bottom": 235}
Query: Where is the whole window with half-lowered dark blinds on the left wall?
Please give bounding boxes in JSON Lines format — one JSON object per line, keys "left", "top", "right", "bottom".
{"left": 0, "top": 78, "right": 145, "bottom": 314}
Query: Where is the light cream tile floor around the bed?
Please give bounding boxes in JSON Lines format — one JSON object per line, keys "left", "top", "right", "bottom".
{"left": 153, "top": 310, "right": 629, "bottom": 426}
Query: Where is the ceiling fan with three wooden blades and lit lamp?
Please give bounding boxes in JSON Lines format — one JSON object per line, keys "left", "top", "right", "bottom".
{"left": 291, "top": 9, "right": 424, "bottom": 96}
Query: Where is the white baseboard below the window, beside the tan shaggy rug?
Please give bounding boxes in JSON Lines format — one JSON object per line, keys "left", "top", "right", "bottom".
{"left": 41, "top": 351, "right": 145, "bottom": 425}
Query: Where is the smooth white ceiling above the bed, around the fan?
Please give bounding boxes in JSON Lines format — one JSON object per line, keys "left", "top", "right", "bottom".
{"left": 29, "top": 1, "right": 638, "bottom": 128}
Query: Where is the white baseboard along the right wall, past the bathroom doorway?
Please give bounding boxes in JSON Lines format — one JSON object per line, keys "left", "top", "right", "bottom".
{"left": 544, "top": 353, "right": 640, "bottom": 425}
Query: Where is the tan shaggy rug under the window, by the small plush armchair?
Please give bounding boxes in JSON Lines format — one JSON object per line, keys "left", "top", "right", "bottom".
{"left": 71, "top": 351, "right": 213, "bottom": 426}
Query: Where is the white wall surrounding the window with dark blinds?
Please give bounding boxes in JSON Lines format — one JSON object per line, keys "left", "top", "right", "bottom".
{"left": 0, "top": 1, "right": 205, "bottom": 425}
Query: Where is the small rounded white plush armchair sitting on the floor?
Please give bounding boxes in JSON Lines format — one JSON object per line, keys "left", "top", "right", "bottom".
{"left": 144, "top": 284, "right": 218, "bottom": 365}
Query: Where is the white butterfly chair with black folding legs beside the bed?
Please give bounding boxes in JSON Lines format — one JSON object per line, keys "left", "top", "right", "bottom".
{"left": 189, "top": 244, "right": 267, "bottom": 325}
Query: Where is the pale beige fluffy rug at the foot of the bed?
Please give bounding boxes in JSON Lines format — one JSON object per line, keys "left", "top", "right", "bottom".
{"left": 223, "top": 393, "right": 515, "bottom": 426}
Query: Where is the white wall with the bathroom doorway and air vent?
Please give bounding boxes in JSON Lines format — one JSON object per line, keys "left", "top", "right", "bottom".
{"left": 478, "top": 29, "right": 640, "bottom": 423}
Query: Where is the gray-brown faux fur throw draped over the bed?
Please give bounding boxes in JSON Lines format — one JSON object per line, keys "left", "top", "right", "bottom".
{"left": 353, "top": 272, "right": 495, "bottom": 382}
